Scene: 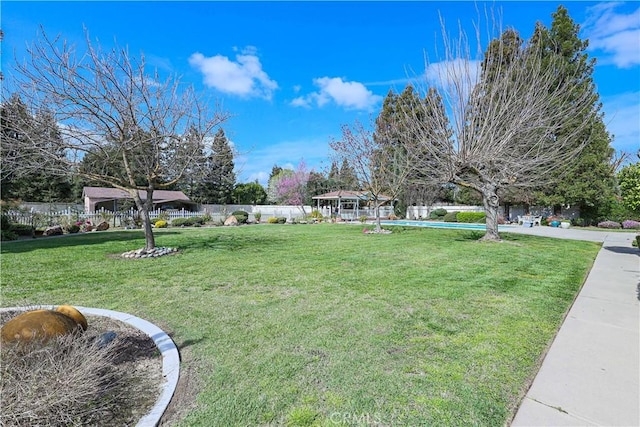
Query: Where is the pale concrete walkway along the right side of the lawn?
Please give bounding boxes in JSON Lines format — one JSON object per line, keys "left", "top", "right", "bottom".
{"left": 509, "top": 227, "right": 640, "bottom": 426}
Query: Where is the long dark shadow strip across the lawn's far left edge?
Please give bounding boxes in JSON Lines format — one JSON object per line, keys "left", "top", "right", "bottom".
{"left": 1, "top": 230, "right": 179, "bottom": 254}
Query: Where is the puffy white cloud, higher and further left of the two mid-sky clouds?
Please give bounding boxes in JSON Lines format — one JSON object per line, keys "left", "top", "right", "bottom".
{"left": 189, "top": 48, "right": 278, "bottom": 99}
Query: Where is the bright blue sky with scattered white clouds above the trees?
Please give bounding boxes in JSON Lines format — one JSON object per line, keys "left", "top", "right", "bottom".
{"left": 1, "top": 1, "right": 640, "bottom": 184}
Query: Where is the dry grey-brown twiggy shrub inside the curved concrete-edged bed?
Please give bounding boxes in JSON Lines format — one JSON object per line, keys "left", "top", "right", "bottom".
{"left": 0, "top": 310, "right": 158, "bottom": 426}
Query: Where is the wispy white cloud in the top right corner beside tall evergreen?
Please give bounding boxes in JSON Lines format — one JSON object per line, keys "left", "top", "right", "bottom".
{"left": 582, "top": 2, "right": 640, "bottom": 68}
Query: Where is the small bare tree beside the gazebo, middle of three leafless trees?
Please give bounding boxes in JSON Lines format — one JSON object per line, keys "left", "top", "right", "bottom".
{"left": 329, "top": 121, "right": 411, "bottom": 232}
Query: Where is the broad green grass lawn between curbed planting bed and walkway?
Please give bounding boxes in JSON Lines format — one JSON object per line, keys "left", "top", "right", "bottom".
{"left": 1, "top": 224, "right": 599, "bottom": 426}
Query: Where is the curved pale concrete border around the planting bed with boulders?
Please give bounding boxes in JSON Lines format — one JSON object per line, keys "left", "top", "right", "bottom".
{"left": 0, "top": 305, "right": 180, "bottom": 427}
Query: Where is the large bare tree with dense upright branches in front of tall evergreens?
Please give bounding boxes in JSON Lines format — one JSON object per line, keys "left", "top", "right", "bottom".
{"left": 405, "top": 20, "right": 597, "bottom": 240}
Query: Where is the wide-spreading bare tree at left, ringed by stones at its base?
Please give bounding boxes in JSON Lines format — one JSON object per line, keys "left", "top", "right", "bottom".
{"left": 3, "top": 30, "right": 227, "bottom": 250}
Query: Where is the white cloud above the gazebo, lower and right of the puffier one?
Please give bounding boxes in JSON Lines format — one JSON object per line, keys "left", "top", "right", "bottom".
{"left": 291, "top": 77, "right": 382, "bottom": 110}
